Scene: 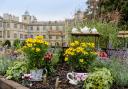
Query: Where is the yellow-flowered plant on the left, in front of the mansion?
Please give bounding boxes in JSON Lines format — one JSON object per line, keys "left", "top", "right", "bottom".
{"left": 23, "top": 36, "right": 48, "bottom": 69}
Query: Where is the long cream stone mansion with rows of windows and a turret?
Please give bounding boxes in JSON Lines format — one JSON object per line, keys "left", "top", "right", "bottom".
{"left": 0, "top": 11, "right": 83, "bottom": 46}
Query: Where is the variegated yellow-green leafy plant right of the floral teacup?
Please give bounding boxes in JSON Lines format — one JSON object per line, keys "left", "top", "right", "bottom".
{"left": 84, "top": 68, "right": 113, "bottom": 89}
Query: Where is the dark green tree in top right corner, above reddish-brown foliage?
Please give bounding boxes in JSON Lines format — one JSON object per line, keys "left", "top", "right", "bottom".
{"left": 98, "top": 0, "right": 128, "bottom": 26}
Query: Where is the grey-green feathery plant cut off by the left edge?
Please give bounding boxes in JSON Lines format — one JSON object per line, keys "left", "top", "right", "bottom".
{"left": 0, "top": 57, "right": 11, "bottom": 75}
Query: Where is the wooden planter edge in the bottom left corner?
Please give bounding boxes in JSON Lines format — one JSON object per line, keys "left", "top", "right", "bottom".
{"left": 0, "top": 76, "right": 29, "bottom": 89}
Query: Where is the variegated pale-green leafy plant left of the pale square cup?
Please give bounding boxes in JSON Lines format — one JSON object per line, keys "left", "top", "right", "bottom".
{"left": 6, "top": 60, "right": 27, "bottom": 80}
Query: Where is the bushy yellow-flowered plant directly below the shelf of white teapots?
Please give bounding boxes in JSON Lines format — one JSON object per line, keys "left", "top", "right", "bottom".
{"left": 64, "top": 41, "right": 97, "bottom": 70}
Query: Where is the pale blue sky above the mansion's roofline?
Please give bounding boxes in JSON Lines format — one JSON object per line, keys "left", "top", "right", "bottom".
{"left": 0, "top": 0, "right": 86, "bottom": 21}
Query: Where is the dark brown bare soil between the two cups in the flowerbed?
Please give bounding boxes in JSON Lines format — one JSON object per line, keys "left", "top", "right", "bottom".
{"left": 30, "top": 63, "right": 83, "bottom": 89}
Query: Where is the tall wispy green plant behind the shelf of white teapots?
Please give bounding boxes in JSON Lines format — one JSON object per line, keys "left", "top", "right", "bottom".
{"left": 76, "top": 20, "right": 119, "bottom": 48}
